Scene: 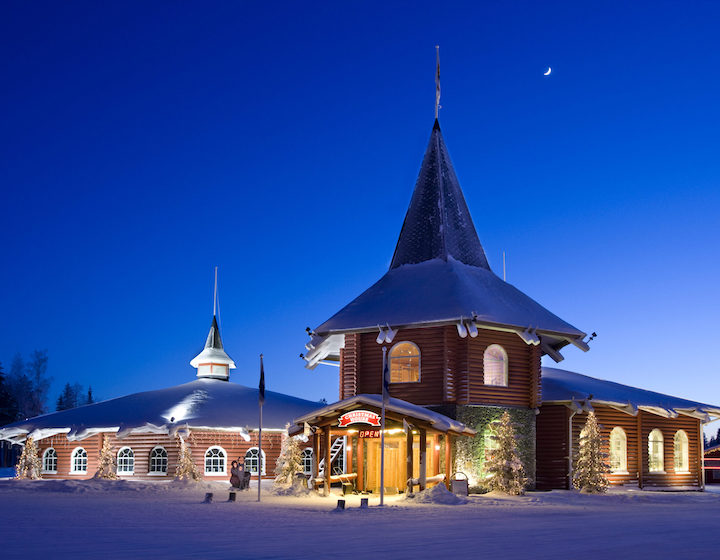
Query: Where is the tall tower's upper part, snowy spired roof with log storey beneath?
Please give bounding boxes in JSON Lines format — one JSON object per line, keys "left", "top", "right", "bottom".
{"left": 304, "top": 119, "right": 587, "bottom": 409}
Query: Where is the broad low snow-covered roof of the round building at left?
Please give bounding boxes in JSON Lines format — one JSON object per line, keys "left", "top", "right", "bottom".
{"left": 0, "top": 379, "right": 319, "bottom": 442}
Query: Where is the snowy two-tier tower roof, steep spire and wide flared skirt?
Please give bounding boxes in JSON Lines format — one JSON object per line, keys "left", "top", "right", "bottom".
{"left": 305, "top": 121, "right": 587, "bottom": 368}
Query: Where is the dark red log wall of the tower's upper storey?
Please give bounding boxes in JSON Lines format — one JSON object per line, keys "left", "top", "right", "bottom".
{"left": 340, "top": 325, "right": 541, "bottom": 408}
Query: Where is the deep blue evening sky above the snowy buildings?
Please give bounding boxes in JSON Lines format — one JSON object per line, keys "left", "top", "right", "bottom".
{"left": 0, "top": 1, "right": 720, "bottom": 428}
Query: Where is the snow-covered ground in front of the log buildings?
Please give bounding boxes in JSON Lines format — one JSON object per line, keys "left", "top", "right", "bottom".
{"left": 0, "top": 480, "right": 720, "bottom": 560}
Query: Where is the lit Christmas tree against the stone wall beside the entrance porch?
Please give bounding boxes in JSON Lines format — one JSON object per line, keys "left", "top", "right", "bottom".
{"left": 485, "top": 411, "right": 528, "bottom": 495}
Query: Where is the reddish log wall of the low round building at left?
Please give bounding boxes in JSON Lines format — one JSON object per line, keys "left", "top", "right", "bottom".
{"left": 38, "top": 431, "right": 286, "bottom": 480}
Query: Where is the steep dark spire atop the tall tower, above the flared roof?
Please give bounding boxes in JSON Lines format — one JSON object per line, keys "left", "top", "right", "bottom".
{"left": 390, "top": 120, "right": 490, "bottom": 270}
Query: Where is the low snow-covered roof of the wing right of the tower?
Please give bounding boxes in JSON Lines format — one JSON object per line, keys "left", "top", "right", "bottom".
{"left": 541, "top": 367, "right": 720, "bottom": 422}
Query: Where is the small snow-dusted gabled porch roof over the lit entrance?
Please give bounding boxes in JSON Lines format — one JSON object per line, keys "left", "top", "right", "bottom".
{"left": 290, "top": 394, "right": 475, "bottom": 435}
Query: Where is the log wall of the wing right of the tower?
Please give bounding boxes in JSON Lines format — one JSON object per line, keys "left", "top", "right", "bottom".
{"left": 537, "top": 405, "right": 702, "bottom": 489}
